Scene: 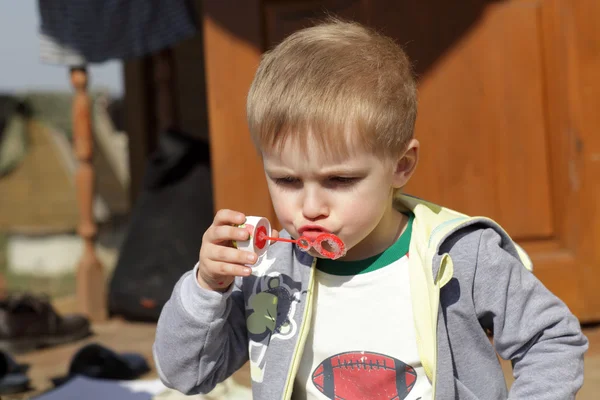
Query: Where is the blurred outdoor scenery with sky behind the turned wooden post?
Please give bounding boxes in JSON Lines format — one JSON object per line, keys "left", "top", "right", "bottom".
{"left": 0, "top": 0, "right": 124, "bottom": 296}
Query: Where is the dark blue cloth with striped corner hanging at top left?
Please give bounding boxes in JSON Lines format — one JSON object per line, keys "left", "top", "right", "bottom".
{"left": 38, "top": 0, "right": 197, "bottom": 66}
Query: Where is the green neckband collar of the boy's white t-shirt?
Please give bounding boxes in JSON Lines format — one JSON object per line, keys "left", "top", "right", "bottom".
{"left": 317, "top": 213, "right": 415, "bottom": 276}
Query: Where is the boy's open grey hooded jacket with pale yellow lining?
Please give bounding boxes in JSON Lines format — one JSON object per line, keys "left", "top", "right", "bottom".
{"left": 154, "top": 196, "right": 588, "bottom": 400}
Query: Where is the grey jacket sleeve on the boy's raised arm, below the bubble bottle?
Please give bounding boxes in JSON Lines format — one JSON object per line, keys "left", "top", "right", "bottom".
{"left": 153, "top": 265, "right": 248, "bottom": 394}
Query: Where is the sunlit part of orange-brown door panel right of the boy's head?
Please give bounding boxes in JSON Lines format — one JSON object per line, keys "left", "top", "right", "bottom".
{"left": 388, "top": 3, "right": 554, "bottom": 240}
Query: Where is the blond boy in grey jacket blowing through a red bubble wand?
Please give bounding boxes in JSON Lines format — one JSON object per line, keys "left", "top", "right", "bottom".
{"left": 154, "top": 21, "right": 587, "bottom": 400}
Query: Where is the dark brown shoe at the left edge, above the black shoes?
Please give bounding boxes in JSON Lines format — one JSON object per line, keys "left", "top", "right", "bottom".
{"left": 0, "top": 294, "right": 91, "bottom": 354}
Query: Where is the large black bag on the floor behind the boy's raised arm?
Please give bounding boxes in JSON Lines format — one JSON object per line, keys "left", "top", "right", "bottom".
{"left": 108, "top": 131, "right": 214, "bottom": 321}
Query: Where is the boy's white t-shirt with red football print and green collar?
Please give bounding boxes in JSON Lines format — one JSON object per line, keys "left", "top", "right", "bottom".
{"left": 293, "top": 216, "right": 431, "bottom": 400}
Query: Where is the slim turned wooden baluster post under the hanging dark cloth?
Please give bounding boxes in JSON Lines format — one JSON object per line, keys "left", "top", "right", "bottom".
{"left": 71, "top": 67, "right": 106, "bottom": 321}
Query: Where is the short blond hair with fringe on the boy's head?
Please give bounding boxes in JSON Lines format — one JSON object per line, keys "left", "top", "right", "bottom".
{"left": 247, "top": 19, "right": 417, "bottom": 156}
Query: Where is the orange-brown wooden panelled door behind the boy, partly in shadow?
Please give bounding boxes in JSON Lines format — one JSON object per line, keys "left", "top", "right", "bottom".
{"left": 205, "top": 0, "right": 600, "bottom": 321}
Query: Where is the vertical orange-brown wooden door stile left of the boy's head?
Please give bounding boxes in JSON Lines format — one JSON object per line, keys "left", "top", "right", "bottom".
{"left": 202, "top": 0, "right": 277, "bottom": 221}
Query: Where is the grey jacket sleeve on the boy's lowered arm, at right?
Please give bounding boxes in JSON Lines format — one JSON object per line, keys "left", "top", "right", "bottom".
{"left": 473, "top": 229, "right": 588, "bottom": 399}
